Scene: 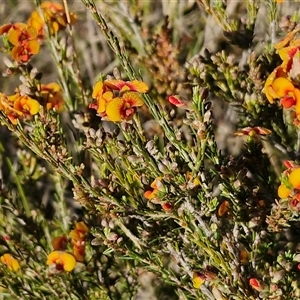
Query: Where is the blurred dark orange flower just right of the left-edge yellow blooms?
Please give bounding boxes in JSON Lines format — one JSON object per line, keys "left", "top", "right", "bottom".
{"left": 40, "top": 82, "right": 64, "bottom": 111}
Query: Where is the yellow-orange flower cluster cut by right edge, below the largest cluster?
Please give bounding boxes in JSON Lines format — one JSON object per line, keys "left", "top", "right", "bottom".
{"left": 278, "top": 161, "right": 300, "bottom": 209}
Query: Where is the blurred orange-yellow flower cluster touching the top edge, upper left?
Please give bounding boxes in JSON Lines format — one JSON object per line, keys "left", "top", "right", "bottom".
{"left": 28, "top": 1, "right": 77, "bottom": 38}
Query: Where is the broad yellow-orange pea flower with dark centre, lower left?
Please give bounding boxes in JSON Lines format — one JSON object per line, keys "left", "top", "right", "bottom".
{"left": 47, "top": 250, "right": 76, "bottom": 272}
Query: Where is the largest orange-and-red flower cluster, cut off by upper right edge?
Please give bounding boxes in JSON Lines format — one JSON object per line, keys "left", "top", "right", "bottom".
{"left": 264, "top": 29, "right": 300, "bottom": 125}
